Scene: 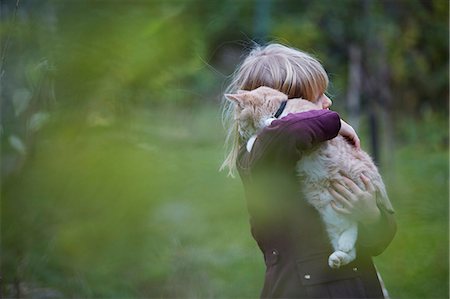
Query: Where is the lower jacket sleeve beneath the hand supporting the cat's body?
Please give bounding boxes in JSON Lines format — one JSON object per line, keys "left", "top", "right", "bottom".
{"left": 357, "top": 206, "right": 397, "bottom": 256}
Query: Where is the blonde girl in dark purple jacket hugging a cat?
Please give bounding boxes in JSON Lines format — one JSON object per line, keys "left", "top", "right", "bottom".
{"left": 222, "top": 44, "right": 396, "bottom": 298}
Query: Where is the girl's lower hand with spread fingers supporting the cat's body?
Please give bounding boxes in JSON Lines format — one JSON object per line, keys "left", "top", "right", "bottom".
{"left": 329, "top": 175, "right": 381, "bottom": 225}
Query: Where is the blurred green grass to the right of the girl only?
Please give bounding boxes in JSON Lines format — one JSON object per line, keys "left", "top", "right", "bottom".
{"left": 376, "top": 142, "right": 449, "bottom": 298}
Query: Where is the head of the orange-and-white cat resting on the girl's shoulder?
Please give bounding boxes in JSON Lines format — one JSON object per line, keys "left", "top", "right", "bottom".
{"left": 225, "top": 86, "right": 288, "bottom": 139}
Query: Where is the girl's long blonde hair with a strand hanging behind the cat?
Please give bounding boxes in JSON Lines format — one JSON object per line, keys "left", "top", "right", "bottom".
{"left": 220, "top": 44, "right": 328, "bottom": 176}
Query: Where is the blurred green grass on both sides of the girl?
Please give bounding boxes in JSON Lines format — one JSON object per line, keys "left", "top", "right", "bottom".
{"left": 1, "top": 105, "right": 448, "bottom": 298}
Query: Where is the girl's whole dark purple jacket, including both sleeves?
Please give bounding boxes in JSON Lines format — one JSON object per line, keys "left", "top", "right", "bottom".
{"left": 237, "top": 110, "right": 396, "bottom": 298}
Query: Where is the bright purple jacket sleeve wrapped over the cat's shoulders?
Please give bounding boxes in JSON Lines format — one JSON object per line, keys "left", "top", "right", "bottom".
{"left": 262, "top": 110, "right": 341, "bottom": 159}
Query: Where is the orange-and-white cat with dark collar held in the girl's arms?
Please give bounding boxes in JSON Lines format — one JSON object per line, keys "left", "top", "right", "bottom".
{"left": 225, "top": 86, "right": 393, "bottom": 268}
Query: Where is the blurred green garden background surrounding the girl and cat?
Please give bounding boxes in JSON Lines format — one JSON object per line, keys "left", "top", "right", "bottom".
{"left": 0, "top": 0, "right": 449, "bottom": 298}
